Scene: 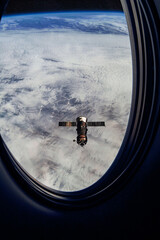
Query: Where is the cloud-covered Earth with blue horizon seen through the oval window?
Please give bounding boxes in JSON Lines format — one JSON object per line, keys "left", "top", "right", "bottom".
{"left": 0, "top": 11, "right": 132, "bottom": 191}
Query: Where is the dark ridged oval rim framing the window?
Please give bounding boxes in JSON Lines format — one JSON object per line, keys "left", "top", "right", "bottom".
{"left": 0, "top": 0, "right": 160, "bottom": 208}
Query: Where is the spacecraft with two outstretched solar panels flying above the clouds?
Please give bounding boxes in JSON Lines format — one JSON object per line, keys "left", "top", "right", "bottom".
{"left": 59, "top": 117, "right": 105, "bottom": 147}
